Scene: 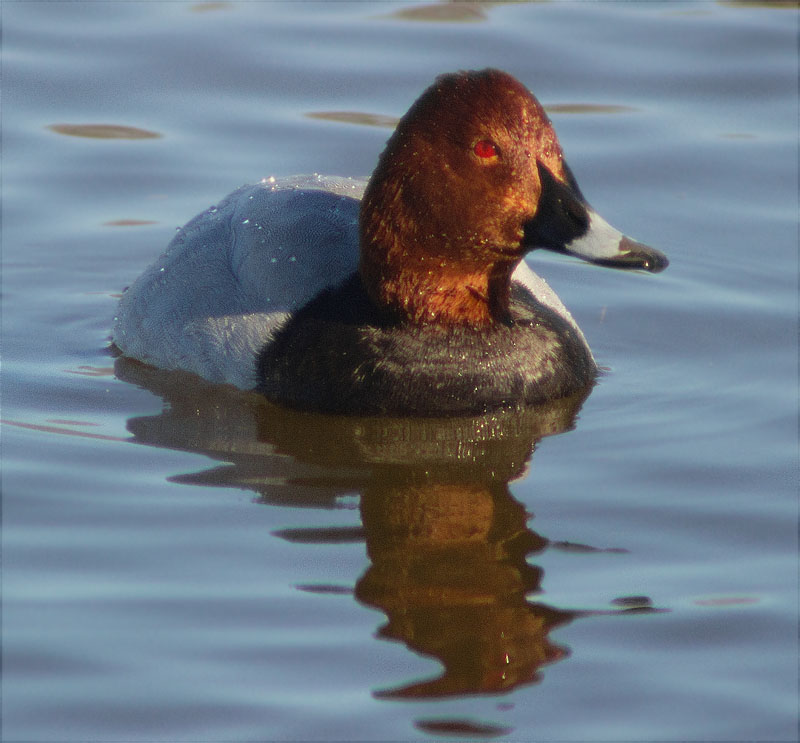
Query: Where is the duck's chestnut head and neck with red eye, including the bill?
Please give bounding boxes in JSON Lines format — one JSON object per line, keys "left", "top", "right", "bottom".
{"left": 359, "top": 69, "right": 667, "bottom": 326}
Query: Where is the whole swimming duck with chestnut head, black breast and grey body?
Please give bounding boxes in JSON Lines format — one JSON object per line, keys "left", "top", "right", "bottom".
{"left": 112, "top": 69, "right": 668, "bottom": 417}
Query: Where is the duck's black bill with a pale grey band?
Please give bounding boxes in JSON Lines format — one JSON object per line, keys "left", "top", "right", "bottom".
{"left": 523, "top": 164, "right": 669, "bottom": 273}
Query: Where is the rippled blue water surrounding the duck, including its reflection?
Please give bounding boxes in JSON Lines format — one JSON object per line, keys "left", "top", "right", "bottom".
{"left": 2, "top": 1, "right": 798, "bottom": 741}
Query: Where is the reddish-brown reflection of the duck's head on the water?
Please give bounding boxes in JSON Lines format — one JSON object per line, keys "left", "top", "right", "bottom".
{"left": 356, "top": 482, "right": 572, "bottom": 697}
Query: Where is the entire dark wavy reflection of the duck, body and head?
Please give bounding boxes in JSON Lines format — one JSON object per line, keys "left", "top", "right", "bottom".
{"left": 115, "top": 358, "right": 620, "bottom": 698}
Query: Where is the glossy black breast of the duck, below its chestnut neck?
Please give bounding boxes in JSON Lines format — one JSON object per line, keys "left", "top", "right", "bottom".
{"left": 257, "top": 275, "right": 597, "bottom": 416}
